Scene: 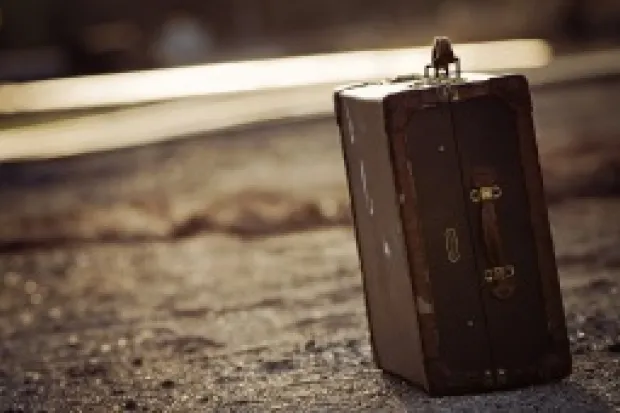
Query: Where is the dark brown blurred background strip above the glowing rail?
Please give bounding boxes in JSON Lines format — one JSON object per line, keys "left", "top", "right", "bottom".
{"left": 0, "top": 0, "right": 620, "bottom": 81}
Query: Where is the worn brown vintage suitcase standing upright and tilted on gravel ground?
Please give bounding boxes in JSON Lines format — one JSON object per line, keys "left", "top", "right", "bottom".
{"left": 335, "top": 38, "right": 571, "bottom": 396}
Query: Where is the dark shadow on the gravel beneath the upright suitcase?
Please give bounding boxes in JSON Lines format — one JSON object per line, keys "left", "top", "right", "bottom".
{"left": 383, "top": 373, "right": 613, "bottom": 413}
